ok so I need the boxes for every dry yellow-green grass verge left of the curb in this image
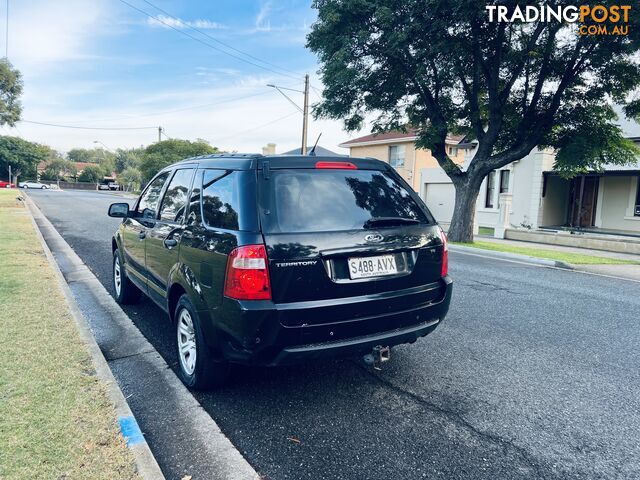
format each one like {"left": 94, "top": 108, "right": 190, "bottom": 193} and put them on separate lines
{"left": 0, "top": 190, "right": 138, "bottom": 479}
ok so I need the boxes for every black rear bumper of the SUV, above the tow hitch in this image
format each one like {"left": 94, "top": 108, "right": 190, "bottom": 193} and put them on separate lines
{"left": 208, "top": 277, "right": 453, "bottom": 366}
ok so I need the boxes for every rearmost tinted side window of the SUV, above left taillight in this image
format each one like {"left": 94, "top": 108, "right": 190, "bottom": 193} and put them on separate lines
{"left": 202, "top": 170, "right": 257, "bottom": 230}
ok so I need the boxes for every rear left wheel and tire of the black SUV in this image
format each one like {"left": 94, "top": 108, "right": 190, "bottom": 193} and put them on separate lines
{"left": 174, "top": 294, "right": 229, "bottom": 390}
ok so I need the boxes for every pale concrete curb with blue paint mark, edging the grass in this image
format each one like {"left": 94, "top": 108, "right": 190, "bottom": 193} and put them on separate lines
{"left": 25, "top": 197, "right": 165, "bottom": 480}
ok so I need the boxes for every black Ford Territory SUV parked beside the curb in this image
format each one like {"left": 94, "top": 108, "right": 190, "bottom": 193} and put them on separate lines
{"left": 109, "top": 154, "right": 452, "bottom": 388}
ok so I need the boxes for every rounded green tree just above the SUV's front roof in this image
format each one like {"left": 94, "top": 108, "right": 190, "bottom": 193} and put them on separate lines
{"left": 140, "top": 139, "right": 219, "bottom": 182}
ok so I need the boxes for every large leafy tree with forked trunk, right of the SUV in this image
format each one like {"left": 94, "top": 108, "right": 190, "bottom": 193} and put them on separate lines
{"left": 307, "top": 0, "right": 640, "bottom": 242}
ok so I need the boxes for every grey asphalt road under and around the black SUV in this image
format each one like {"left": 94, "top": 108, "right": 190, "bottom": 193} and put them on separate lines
{"left": 29, "top": 191, "right": 640, "bottom": 480}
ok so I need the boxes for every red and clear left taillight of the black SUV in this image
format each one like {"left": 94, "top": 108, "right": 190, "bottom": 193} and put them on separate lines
{"left": 224, "top": 245, "right": 271, "bottom": 300}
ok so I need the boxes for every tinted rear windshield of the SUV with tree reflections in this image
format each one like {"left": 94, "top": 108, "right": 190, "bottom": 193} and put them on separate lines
{"left": 263, "top": 170, "right": 431, "bottom": 233}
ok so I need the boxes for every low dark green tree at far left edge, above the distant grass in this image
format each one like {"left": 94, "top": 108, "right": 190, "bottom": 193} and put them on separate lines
{"left": 0, "top": 136, "right": 51, "bottom": 180}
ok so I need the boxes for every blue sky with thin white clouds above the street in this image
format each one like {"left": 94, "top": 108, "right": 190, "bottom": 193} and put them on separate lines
{"left": 0, "top": 0, "right": 360, "bottom": 153}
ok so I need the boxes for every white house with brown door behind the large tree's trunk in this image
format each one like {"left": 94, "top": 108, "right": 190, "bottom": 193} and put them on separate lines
{"left": 419, "top": 138, "right": 640, "bottom": 236}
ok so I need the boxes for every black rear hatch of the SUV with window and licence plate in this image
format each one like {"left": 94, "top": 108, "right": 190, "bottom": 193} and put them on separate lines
{"left": 258, "top": 162, "right": 443, "bottom": 326}
